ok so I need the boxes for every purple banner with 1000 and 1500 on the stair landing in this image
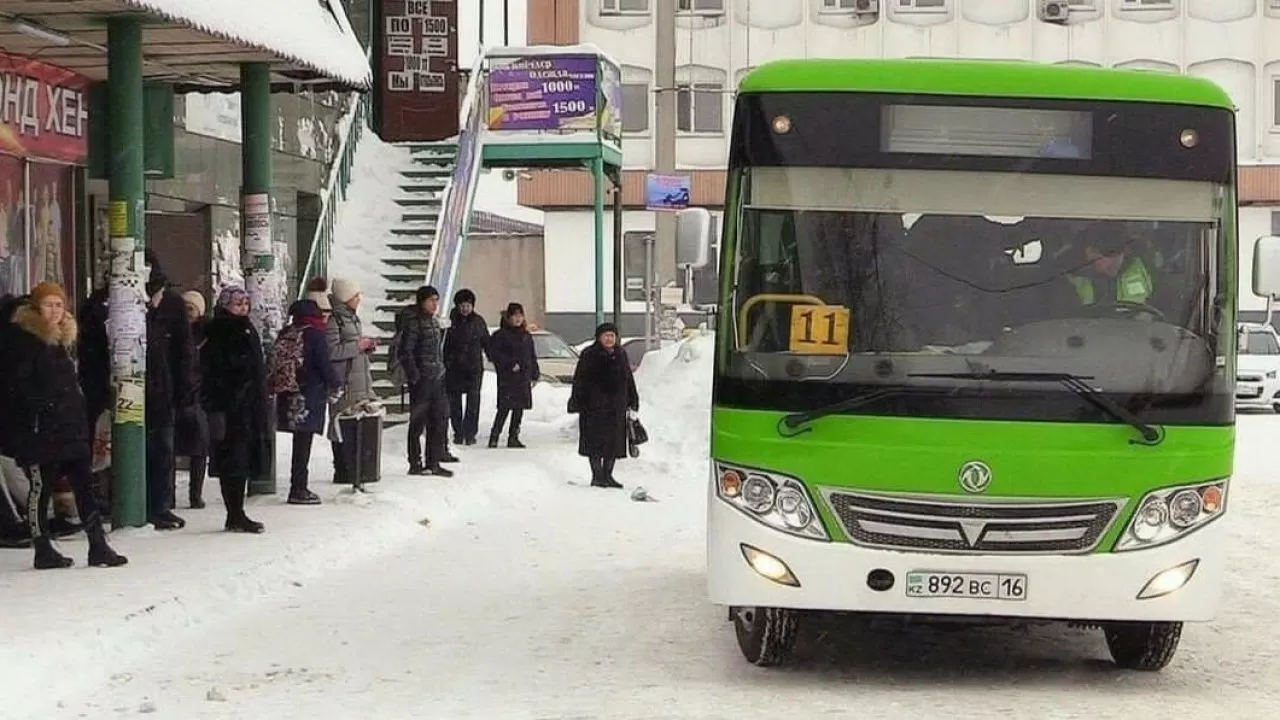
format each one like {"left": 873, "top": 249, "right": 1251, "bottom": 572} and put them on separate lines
{"left": 489, "top": 55, "right": 598, "bottom": 131}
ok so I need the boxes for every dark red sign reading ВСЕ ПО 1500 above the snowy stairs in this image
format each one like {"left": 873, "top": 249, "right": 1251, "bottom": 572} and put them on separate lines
{"left": 374, "top": 0, "right": 461, "bottom": 142}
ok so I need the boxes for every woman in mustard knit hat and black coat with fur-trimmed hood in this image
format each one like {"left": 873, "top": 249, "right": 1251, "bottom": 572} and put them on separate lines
{"left": 0, "top": 282, "right": 128, "bottom": 570}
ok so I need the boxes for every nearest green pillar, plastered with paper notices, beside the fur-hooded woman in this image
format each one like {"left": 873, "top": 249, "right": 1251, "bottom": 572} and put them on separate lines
{"left": 106, "top": 15, "right": 147, "bottom": 528}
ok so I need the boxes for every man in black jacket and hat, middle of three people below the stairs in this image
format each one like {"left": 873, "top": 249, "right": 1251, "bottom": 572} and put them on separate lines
{"left": 444, "top": 290, "right": 489, "bottom": 445}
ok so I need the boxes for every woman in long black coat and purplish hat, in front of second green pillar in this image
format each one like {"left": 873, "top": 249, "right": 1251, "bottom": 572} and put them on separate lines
{"left": 200, "top": 287, "right": 271, "bottom": 533}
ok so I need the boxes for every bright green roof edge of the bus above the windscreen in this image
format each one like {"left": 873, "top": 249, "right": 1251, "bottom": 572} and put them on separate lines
{"left": 739, "top": 58, "right": 1235, "bottom": 110}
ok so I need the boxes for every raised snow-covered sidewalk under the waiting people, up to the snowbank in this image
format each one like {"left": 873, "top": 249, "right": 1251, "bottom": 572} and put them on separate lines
{"left": 0, "top": 338, "right": 709, "bottom": 716}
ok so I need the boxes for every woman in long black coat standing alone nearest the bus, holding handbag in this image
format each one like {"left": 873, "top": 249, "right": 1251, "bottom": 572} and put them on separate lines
{"left": 568, "top": 323, "right": 640, "bottom": 488}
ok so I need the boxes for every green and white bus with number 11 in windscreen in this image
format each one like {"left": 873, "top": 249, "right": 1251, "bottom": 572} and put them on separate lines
{"left": 677, "top": 59, "right": 1280, "bottom": 670}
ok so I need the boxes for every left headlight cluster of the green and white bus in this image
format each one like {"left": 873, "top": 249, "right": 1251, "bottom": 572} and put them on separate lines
{"left": 716, "top": 462, "right": 831, "bottom": 541}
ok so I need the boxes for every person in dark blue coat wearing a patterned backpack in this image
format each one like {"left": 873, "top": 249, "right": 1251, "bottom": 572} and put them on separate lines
{"left": 273, "top": 300, "right": 342, "bottom": 505}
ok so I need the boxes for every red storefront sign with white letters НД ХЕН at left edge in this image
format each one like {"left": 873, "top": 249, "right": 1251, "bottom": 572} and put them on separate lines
{"left": 0, "top": 53, "right": 88, "bottom": 164}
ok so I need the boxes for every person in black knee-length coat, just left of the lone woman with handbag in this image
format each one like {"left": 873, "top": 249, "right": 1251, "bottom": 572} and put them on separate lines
{"left": 489, "top": 302, "right": 540, "bottom": 448}
